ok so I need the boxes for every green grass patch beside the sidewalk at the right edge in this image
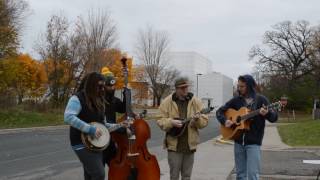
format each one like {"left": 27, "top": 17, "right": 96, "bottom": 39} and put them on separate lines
{"left": 278, "top": 115, "right": 320, "bottom": 146}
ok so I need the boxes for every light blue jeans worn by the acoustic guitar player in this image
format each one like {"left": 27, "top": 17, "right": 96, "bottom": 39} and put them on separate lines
{"left": 234, "top": 143, "right": 261, "bottom": 180}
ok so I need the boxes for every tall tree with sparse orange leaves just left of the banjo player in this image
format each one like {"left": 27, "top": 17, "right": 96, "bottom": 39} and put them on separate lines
{"left": 36, "top": 15, "right": 72, "bottom": 106}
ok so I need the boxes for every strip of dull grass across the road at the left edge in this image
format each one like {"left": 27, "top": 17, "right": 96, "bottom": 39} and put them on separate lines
{"left": 0, "top": 108, "right": 64, "bottom": 129}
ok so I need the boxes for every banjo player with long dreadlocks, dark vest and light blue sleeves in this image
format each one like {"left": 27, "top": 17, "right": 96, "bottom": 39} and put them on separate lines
{"left": 64, "top": 72, "right": 120, "bottom": 180}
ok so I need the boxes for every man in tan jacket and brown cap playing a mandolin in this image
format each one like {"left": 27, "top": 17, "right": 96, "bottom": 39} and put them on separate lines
{"left": 157, "top": 77, "right": 208, "bottom": 180}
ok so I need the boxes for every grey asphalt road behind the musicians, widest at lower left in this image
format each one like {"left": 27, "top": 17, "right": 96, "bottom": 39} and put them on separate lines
{"left": 0, "top": 118, "right": 218, "bottom": 179}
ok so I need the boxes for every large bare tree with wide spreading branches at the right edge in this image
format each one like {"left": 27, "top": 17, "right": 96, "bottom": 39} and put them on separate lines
{"left": 250, "top": 21, "right": 320, "bottom": 110}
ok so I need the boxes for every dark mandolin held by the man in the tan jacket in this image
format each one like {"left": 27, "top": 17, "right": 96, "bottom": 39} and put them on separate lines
{"left": 168, "top": 107, "right": 214, "bottom": 137}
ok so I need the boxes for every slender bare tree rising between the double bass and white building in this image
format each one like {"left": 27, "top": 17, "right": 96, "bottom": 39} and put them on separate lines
{"left": 135, "top": 26, "right": 176, "bottom": 106}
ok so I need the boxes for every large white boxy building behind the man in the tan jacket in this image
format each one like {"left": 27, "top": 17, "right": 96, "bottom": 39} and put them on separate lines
{"left": 167, "top": 52, "right": 233, "bottom": 107}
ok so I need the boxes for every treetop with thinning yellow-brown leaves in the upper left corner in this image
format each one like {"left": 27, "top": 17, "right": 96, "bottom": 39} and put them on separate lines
{"left": 0, "top": 0, "right": 29, "bottom": 58}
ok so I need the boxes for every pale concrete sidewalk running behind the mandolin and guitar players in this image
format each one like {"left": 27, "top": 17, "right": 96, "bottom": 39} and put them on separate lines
{"left": 159, "top": 121, "right": 290, "bottom": 180}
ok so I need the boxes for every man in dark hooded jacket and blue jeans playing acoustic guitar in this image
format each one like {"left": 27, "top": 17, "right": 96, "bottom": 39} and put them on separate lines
{"left": 216, "top": 75, "right": 278, "bottom": 180}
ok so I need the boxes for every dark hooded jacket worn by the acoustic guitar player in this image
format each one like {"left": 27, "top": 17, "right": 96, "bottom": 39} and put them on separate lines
{"left": 216, "top": 94, "right": 278, "bottom": 145}
